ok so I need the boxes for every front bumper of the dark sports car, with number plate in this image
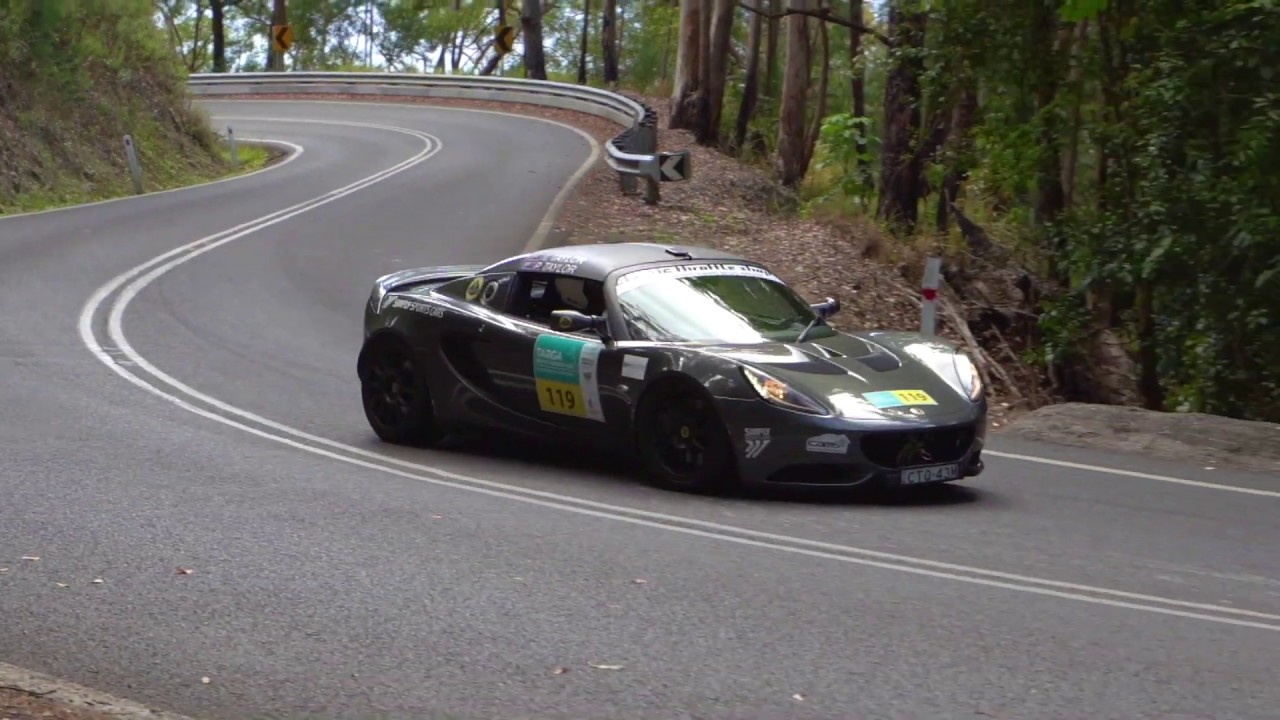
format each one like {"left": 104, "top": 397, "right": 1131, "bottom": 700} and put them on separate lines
{"left": 719, "top": 398, "right": 987, "bottom": 487}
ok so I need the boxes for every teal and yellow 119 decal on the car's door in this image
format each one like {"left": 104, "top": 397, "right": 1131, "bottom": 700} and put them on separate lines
{"left": 534, "top": 334, "right": 604, "bottom": 421}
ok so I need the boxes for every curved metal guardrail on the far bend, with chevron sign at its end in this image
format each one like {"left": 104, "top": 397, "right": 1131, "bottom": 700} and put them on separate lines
{"left": 188, "top": 72, "right": 692, "bottom": 205}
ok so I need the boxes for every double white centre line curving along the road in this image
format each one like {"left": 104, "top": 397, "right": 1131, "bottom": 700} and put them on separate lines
{"left": 78, "top": 112, "right": 1280, "bottom": 632}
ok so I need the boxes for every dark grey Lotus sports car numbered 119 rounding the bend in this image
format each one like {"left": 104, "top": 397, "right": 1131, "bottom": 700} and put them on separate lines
{"left": 357, "top": 243, "right": 987, "bottom": 491}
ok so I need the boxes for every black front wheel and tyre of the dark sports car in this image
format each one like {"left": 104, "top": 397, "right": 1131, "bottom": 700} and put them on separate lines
{"left": 636, "top": 382, "right": 737, "bottom": 493}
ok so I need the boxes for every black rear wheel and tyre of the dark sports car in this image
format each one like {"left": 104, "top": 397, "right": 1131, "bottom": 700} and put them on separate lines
{"left": 360, "top": 337, "right": 444, "bottom": 447}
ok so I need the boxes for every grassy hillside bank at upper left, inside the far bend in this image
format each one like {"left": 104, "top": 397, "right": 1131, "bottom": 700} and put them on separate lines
{"left": 0, "top": 0, "right": 248, "bottom": 213}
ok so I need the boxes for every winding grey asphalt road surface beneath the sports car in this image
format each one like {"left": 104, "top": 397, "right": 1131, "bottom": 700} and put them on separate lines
{"left": 0, "top": 102, "right": 1280, "bottom": 720}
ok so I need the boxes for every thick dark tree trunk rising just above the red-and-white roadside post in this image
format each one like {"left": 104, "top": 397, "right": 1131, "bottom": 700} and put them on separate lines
{"left": 877, "top": 0, "right": 925, "bottom": 233}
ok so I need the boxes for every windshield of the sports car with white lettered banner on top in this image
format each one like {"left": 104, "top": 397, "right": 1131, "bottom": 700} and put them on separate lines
{"left": 618, "top": 266, "right": 835, "bottom": 343}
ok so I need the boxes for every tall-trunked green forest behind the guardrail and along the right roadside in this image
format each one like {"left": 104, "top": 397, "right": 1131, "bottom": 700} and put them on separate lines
{"left": 155, "top": 0, "right": 1280, "bottom": 421}
